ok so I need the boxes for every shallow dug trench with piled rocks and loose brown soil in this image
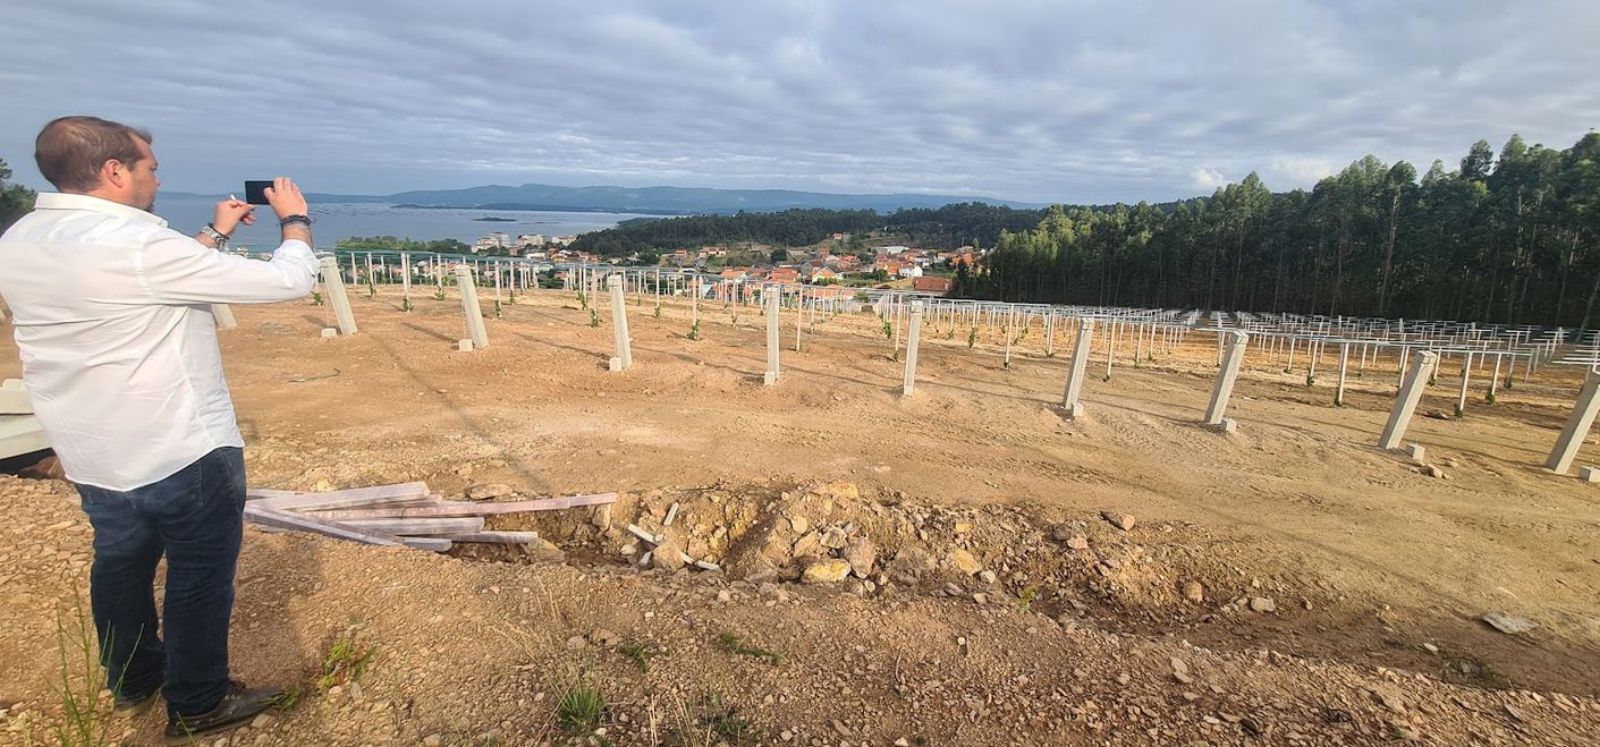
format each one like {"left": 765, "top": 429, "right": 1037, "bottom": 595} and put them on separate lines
{"left": 451, "top": 483, "right": 1600, "bottom": 696}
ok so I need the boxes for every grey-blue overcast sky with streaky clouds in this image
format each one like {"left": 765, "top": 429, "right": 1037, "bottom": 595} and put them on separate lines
{"left": 0, "top": 0, "right": 1600, "bottom": 203}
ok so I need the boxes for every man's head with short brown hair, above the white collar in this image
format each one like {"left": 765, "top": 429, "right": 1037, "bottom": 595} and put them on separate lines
{"left": 34, "top": 117, "right": 154, "bottom": 192}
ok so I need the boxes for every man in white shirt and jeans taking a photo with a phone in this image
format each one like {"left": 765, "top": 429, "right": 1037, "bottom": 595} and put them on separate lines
{"left": 0, "top": 117, "right": 317, "bottom": 737}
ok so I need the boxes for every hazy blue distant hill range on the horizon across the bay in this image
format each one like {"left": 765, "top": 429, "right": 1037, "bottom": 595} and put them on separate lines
{"left": 162, "top": 184, "right": 1042, "bottom": 216}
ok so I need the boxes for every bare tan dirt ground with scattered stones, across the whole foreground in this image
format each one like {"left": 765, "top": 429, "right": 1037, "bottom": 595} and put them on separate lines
{"left": 0, "top": 290, "right": 1600, "bottom": 745}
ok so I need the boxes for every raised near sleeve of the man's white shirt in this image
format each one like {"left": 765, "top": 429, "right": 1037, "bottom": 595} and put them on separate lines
{"left": 134, "top": 229, "right": 318, "bottom": 304}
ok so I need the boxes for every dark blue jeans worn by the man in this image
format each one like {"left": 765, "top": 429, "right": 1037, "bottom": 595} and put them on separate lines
{"left": 77, "top": 446, "right": 245, "bottom": 717}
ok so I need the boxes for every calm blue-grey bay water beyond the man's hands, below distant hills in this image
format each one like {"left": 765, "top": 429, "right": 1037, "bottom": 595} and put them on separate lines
{"left": 155, "top": 195, "right": 661, "bottom": 250}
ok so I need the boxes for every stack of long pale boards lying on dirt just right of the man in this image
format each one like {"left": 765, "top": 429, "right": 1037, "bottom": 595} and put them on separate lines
{"left": 245, "top": 483, "right": 616, "bottom": 552}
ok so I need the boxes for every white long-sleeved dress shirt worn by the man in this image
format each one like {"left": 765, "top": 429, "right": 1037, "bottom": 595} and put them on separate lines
{"left": 0, "top": 194, "right": 317, "bottom": 491}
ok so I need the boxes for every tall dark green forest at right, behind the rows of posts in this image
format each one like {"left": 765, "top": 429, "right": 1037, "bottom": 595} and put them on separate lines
{"left": 955, "top": 133, "right": 1600, "bottom": 328}
